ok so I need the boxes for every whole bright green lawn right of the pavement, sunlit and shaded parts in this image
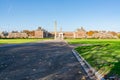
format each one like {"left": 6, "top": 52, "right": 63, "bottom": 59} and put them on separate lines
{"left": 66, "top": 39, "right": 120, "bottom": 77}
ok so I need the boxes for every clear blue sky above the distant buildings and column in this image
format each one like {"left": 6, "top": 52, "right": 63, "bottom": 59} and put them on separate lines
{"left": 0, "top": 0, "right": 120, "bottom": 32}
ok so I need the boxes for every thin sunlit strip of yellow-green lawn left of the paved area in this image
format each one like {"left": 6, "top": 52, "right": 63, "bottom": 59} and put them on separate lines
{"left": 0, "top": 39, "right": 49, "bottom": 45}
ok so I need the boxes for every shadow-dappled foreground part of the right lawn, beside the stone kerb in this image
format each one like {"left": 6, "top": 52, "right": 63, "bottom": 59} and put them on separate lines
{"left": 75, "top": 44, "right": 120, "bottom": 80}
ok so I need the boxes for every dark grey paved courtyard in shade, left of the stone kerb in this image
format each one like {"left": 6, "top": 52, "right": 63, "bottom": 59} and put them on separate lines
{"left": 0, "top": 41, "right": 88, "bottom": 80}
